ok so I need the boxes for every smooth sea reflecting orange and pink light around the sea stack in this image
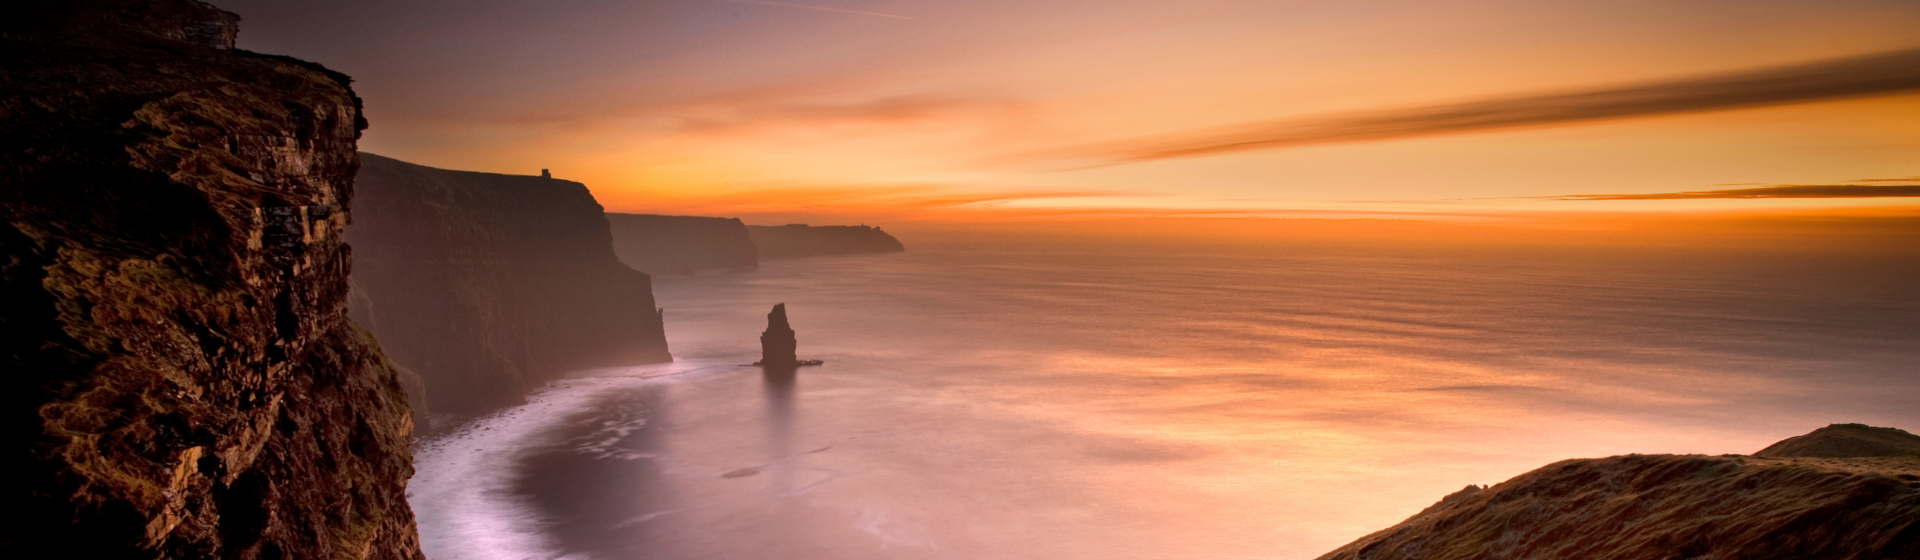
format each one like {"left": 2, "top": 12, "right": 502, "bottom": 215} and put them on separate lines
{"left": 411, "top": 240, "right": 1920, "bottom": 560}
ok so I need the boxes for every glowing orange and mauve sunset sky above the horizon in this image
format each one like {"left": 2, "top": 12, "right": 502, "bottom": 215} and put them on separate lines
{"left": 215, "top": 0, "right": 1920, "bottom": 231}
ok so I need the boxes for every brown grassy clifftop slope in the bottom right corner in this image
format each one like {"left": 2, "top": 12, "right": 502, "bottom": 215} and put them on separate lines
{"left": 1321, "top": 424, "right": 1920, "bottom": 560}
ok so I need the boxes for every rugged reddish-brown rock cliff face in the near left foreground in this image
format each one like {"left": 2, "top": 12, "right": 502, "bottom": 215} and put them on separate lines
{"left": 0, "top": 0, "right": 420, "bottom": 558}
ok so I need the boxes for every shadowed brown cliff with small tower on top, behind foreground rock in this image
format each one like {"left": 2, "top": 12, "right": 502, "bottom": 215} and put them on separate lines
{"left": 346, "top": 153, "right": 672, "bottom": 416}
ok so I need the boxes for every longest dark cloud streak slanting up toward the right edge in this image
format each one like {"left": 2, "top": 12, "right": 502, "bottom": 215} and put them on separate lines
{"left": 1012, "top": 48, "right": 1920, "bottom": 167}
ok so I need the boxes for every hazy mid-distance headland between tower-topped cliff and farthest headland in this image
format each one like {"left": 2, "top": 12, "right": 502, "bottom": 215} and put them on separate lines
{"left": 607, "top": 213, "right": 760, "bottom": 276}
